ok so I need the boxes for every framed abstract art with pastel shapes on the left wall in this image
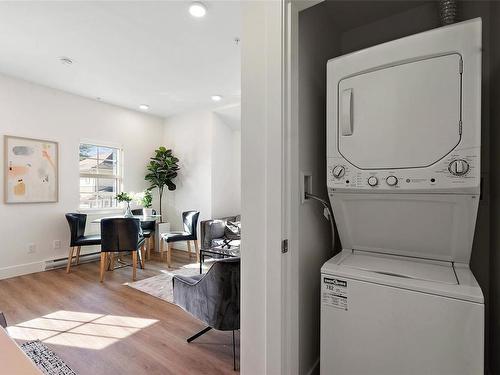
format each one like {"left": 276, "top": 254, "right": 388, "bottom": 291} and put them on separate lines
{"left": 4, "top": 135, "right": 59, "bottom": 203}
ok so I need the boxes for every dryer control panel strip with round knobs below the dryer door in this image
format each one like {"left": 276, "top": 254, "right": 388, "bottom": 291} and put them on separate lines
{"left": 327, "top": 148, "right": 480, "bottom": 191}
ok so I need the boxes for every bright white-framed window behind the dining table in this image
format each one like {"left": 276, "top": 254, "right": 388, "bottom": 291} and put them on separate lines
{"left": 80, "top": 143, "right": 122, "bottom": 209}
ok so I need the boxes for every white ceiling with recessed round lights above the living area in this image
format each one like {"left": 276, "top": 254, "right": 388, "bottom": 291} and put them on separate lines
{"left": 0, "top": 1, "right": 241, "bottom": 117}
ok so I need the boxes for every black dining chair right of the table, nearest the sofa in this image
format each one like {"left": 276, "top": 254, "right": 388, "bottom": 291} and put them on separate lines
{"left": 160, "top": 211, "right": 200, "bottom": 268}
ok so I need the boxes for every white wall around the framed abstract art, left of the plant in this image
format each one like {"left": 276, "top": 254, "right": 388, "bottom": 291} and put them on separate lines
{"left": 0, "top": 75, "right": 163, "bottom": 278}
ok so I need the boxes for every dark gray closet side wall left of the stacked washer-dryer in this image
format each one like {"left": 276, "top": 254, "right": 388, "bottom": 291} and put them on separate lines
{"left": 297, "top": 7, "right": 340, "bottom": 374}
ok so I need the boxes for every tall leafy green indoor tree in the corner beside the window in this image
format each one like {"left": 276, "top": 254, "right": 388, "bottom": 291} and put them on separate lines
{"left": 144, "top": 146, "right": 179, "bottom": 221}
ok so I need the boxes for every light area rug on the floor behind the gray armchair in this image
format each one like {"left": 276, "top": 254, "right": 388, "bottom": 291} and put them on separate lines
{"left": 127, "top": 263, "right": 205, "bottom": 303}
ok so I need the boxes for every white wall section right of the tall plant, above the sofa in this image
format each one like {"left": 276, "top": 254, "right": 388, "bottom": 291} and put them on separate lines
{"left": 163, "top": 111, "right": 241, "bottom": 241}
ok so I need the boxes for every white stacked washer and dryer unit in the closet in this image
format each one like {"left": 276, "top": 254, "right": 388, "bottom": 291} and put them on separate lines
{"left": 321, "top": 19, "right": 484, "bottom": 375}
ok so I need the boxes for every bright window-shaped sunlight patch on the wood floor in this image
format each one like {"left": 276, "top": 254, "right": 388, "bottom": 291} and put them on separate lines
{"left": 7, "top": 310, "right": 158, "bottom": 350}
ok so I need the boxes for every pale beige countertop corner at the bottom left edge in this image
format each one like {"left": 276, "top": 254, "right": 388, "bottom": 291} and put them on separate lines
{"left": 0, "top": 327, "right": 43, "bottom": 375}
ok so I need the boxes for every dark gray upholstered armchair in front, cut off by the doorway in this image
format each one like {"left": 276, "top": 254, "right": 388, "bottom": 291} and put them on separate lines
{"left": 172, "top": 258, "right": 240, "bottom": 370}
